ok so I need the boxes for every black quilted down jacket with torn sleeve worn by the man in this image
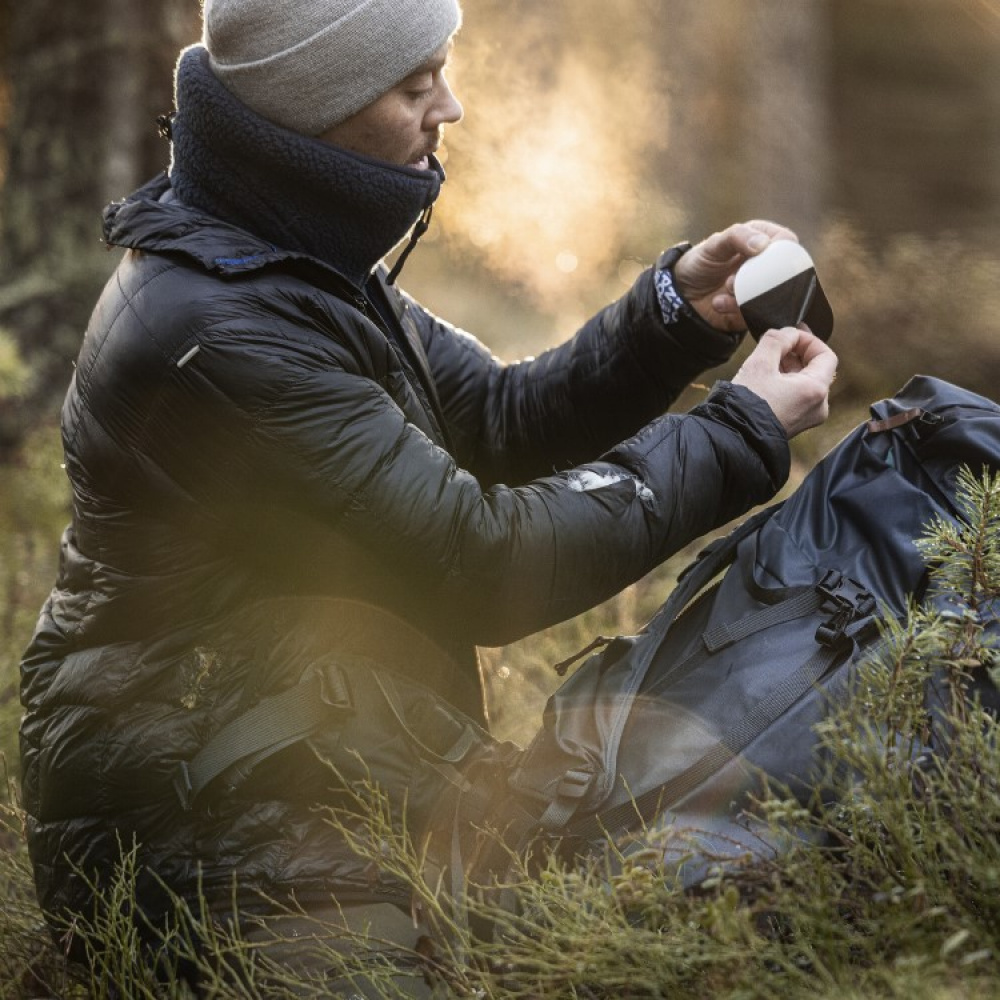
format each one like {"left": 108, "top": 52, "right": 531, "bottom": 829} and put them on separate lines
{"left": 22, "top": 172, "right": 788, "bottom": 928}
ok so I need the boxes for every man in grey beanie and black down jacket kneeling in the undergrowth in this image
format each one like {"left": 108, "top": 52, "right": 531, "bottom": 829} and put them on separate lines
{"left": 22, "top": 0, "right": 836, "bottom": 988}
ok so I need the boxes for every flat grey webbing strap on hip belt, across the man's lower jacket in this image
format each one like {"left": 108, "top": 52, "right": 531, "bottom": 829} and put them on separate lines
{"left": 174, "top": 664, "right": 351, "bottom": 810}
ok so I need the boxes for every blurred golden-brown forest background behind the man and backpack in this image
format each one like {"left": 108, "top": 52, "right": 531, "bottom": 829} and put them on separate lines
{"left": 0, "top": 0, "right": 1000, "bottom": 770}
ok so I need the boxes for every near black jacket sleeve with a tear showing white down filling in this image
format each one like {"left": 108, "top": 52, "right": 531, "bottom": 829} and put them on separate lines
{"left": 178, "top": 320, "right": 789, "bottom": 645}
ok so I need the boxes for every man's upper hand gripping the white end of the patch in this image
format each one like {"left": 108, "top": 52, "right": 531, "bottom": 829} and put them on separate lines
{"left": 674, "top": 219, "right": 798, "bottom": 333}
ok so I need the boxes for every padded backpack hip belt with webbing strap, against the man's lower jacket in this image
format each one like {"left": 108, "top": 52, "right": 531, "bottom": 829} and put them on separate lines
{"left": 170, "top": 597, "right": 488, "bottom": 809}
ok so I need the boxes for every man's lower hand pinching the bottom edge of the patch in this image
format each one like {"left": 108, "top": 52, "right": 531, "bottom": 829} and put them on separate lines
{"left": 733, "top": 326, "right": 837, "bottom": 438}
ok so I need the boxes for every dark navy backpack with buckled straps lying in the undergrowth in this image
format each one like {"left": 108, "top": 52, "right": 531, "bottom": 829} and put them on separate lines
{"left": 472, "top": 376, "right": 1000, "bottom": 884}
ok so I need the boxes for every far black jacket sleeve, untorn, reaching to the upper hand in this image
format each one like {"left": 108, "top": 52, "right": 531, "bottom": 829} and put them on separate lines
{"left": 398, "top": 270, "right": 741, "bottom": 483}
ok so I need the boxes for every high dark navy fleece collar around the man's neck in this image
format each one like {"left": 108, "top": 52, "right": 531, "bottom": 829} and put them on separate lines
{"left": 162, "top": 45, "right": 444, "bottom": 288}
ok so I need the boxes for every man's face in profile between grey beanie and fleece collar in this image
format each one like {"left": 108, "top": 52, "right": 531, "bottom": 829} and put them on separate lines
{"left": 318, "top": 42, "right": 462, "bottom": 170}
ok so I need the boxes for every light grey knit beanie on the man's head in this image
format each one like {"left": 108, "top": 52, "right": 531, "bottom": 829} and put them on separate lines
{"left": 203, "top": 0, "right": 462, "bottom": 135}
